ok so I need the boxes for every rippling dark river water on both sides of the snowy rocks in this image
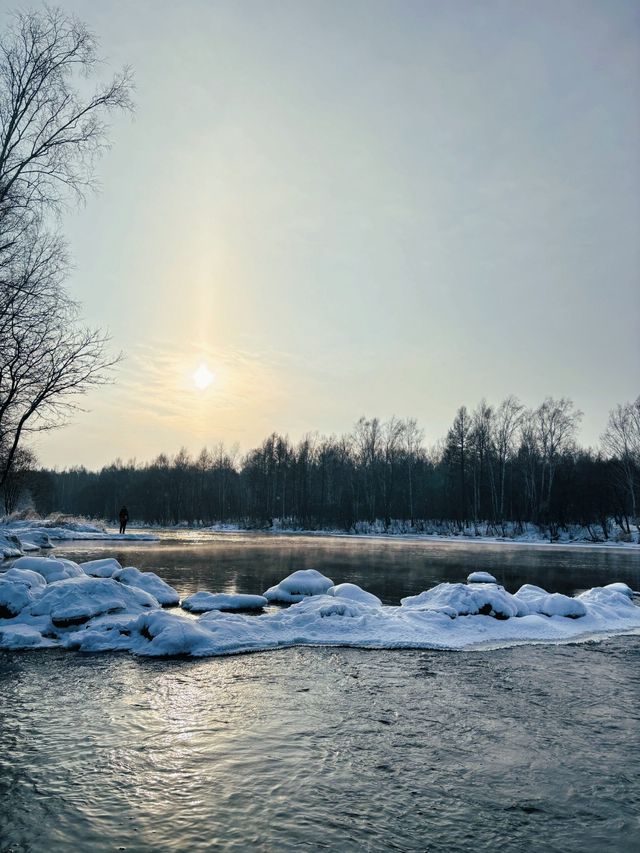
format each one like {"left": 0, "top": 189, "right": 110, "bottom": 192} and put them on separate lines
{"left": 0, "top": 534, "right": 640, "bottom": 853}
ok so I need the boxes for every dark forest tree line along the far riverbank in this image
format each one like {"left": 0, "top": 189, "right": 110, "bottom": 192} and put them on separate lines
{"left": 10, "top": 397, "right": 640, "bottom": 538}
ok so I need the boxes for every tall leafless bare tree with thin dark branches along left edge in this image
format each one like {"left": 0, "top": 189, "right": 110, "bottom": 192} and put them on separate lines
{"left": 0, "top": 8, "right": 131, "bottom": 486}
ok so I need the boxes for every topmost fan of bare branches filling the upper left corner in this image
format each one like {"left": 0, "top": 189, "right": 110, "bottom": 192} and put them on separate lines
{"left": 0, "top": 8, "right": 131, "bottom": 225}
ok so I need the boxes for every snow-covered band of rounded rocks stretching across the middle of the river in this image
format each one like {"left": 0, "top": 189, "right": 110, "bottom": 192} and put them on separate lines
{"left": 0, "top": 557, "right": 640, "bottom": 657}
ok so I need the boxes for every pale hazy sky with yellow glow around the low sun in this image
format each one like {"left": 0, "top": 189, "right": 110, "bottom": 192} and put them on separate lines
{"left": 2, "top": 0, "right": 640, "bottom": 466}
